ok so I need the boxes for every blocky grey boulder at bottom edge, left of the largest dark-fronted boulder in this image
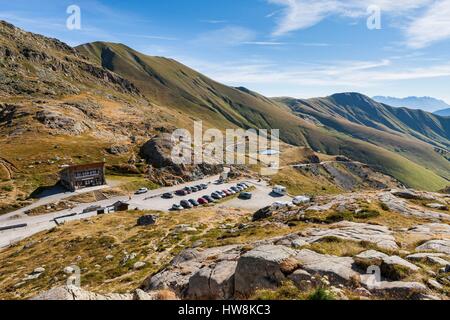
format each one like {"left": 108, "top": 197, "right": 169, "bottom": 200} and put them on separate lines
{"left": 187, "top": 261, "right": 237, "bottom": 300}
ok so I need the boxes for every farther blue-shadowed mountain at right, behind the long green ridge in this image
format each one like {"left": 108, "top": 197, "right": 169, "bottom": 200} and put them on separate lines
{"left": 276, "top": 94, "right": 450, "bottom": 188}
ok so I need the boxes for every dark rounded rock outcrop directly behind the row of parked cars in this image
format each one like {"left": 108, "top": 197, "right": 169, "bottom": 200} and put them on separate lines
{"left": 140, "top": 133, "right": 223, "bottom": 185}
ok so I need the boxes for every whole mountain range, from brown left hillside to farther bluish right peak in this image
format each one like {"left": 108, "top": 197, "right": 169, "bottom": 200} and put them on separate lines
{"left": 0, "top": 22, "right": 450, "bottom": 195}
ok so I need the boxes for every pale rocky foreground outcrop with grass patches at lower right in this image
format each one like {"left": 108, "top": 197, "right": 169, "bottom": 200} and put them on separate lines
{"left": 29, "top": 190, "right": 450, "bottom": 300}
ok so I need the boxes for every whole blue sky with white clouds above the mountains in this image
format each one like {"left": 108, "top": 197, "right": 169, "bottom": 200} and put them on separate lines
{"left": 0, "top": 0, "right": 450, "bottom": 110}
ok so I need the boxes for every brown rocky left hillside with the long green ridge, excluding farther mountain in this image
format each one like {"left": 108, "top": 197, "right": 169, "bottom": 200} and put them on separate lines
{"left": 0, "top": 19, "right": 450, "bottom": 202}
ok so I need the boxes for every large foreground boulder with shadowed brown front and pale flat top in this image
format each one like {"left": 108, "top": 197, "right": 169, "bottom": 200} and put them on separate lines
{"left": 235, "top": 245, "right": 296, "bottom": 297}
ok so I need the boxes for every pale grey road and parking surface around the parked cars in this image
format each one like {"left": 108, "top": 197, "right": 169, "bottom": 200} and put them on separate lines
{"left": 0, "top": 172, "right": 292, "bottom": 248}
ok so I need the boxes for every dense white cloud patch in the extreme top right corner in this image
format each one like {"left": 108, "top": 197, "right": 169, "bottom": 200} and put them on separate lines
{"left": 406, "top": 0, "right": 450, "bottom": 48}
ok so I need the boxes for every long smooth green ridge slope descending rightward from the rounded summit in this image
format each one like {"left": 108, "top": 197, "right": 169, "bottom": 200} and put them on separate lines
{"left": 77, "top": 42, "right": 449, "bottom": 189}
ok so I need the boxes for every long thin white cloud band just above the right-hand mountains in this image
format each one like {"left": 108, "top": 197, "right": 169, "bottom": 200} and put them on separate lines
{"left": 180, "top": 59, "right": 450, "bottom": 93}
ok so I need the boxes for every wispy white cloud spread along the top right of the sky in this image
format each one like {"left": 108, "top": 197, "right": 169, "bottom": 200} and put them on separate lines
{"left": 267, "top": 0, "right": 450, "bottom": 48}
